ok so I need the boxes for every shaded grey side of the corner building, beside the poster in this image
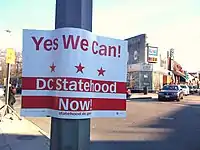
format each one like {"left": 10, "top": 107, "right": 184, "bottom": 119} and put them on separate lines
{"left": 126, "top": 34, "right": 152, "bottom": 90}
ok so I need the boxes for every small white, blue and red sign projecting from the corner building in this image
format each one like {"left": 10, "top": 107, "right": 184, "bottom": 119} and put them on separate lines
{"left": 147, "top": 46, "right": 158, "bottom": 63}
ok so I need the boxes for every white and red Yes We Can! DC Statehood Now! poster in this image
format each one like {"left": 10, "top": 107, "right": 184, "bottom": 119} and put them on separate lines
{"left": 21, "top": 28, "right": 128, "bottom": 119}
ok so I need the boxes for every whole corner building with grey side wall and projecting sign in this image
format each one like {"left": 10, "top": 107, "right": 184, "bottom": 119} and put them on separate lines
{"left": 126, "top": 34, "right": 172, "bottom": 92}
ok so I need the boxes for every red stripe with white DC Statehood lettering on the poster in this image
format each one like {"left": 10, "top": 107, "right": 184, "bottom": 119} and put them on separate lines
{"left": 22, "top": 77, "right": 126, "bottom": 93}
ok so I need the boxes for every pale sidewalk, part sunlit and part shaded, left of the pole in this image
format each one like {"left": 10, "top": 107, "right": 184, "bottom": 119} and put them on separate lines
{"left": 0, "top": 102, "right": 49, "bottom": 150}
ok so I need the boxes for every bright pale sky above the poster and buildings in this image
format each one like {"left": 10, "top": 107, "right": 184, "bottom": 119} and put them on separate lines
{"left": 0, "top": 0, "right": 200, "bottom": 71}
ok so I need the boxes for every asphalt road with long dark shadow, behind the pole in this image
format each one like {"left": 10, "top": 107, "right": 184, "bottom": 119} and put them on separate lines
{"left": 3, "top": 96, "right": 200, "bottom": 150}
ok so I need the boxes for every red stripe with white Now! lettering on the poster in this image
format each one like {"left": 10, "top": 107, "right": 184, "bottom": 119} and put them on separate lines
{"left": 22, "top": 96, "right": 126, "bottom": 111}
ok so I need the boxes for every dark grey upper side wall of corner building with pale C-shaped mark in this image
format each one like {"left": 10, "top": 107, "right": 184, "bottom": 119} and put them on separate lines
{"left": 126, "top": 34, "right": 146, "bottom": 65}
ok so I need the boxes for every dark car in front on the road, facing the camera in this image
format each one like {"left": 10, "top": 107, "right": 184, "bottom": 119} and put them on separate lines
{"left": 158, "top": 85, "right": 184, "bottom": 101}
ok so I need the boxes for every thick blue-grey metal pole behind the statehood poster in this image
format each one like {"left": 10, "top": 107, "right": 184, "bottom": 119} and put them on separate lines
{"left": 50, "top": 0, "right": 92, "bottom": 150}
